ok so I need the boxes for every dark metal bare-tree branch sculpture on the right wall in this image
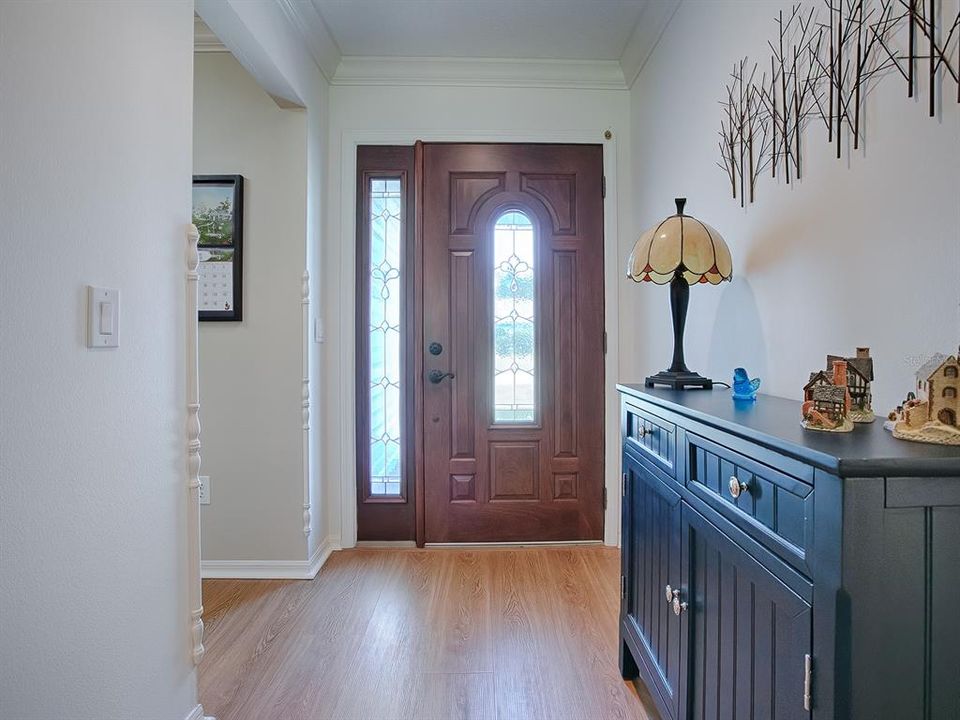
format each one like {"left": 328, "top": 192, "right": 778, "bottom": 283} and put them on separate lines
{"left": 718, "top": 0, "right": 960, "bottom": 206}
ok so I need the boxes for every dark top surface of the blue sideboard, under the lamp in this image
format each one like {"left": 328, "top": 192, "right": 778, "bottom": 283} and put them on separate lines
{"left": 617, "top": 384, "right": 960, "bottom": 479}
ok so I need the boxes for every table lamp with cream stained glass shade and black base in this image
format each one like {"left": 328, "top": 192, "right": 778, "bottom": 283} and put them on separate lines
{"left": 627, "top": 198, "right": 733, "bottom": 390}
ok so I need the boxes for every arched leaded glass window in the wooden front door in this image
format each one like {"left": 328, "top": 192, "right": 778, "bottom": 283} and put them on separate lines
{"left": 493, "top": 210, "right": 537, "bottom": 423}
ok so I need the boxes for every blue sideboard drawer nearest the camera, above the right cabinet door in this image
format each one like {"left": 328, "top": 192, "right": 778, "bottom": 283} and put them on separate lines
{"left": 685, "top": 433, "right": 813, "bottom": 575}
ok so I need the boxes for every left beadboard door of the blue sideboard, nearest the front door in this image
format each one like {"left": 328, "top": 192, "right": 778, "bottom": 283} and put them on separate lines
{"left": 623, "top": 453, "right": 681, "bottom": 717}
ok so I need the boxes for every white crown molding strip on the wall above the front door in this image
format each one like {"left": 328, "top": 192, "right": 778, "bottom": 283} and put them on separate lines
{"left": 331, "top": 56, "right": 627, "bottom": 90}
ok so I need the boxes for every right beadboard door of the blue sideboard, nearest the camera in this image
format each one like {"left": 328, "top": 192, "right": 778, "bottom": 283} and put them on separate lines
{"left": 680, "top": 503, "right": 811, "bottom": 720}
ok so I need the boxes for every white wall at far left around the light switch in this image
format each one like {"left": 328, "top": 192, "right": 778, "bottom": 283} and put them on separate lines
{"left": 0, "top": 0, "right": 196, "bottom": 720}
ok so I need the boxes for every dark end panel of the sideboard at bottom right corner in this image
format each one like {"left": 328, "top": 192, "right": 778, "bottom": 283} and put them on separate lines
{"left": 838, "top": 477, "right": 960, "bottom": 720}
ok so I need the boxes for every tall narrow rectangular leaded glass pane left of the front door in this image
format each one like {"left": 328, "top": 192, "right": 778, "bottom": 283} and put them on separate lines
{"left": 368, "top": 178, "right": 403, "bottom": 497}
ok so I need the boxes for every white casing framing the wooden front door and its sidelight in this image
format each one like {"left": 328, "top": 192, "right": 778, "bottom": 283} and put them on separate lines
{"left": 327, "top": 126, "right": 621, "bottom": 548}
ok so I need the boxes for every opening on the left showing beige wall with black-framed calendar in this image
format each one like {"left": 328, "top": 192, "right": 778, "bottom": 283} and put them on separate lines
{"left": 192, "top": 18, "right": 312, "bottom": 578}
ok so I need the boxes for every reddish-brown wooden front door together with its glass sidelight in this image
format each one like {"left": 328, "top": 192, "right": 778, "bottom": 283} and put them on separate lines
{"left": 356, "top": 143, "right": 605, "bottom": 545}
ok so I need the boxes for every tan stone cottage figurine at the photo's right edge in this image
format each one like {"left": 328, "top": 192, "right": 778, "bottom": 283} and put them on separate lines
{"left": 886, "top": 349, "right": 960, "bottom": 445}
